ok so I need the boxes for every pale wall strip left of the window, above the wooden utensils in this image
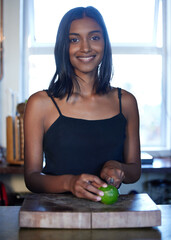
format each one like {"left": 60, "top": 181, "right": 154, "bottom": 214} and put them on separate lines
{"left": 0, "top": 0, "right": 22, "bottom": 147}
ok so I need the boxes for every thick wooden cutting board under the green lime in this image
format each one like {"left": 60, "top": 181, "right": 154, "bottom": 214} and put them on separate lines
{"left": 19, "top": 194, "right": 161, "bottom": 229}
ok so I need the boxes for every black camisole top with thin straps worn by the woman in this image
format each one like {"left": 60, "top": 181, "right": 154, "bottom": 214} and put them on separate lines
{"left": 42, "top": 88, "right": 127, "bottom": 176}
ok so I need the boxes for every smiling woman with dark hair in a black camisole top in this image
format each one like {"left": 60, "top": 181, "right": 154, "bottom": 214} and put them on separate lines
{"left": 24, "top": 7, "right": 141, "bottom": 201}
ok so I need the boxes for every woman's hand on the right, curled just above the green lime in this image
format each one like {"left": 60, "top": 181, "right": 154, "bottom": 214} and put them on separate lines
{"left": 100, "top": 160, "right": 125, "bottom": 188}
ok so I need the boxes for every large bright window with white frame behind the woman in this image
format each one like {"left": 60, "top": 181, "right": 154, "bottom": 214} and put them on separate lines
{"left": 24, "top": 0, "right": 170, "bottom": 153}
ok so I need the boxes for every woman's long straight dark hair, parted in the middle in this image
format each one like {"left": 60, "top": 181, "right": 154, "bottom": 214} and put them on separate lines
{"left": 48, "top": 7, "right": 112, "bottom": 98}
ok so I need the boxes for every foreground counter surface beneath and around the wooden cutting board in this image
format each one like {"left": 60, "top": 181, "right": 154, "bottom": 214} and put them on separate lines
{"left": 0, "top": 205, "right": 171, "bottom": 240}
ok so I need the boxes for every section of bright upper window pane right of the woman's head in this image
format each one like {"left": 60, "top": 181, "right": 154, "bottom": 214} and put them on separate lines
{"left": 98, "top": 0, "right": 155, "bottom": 44}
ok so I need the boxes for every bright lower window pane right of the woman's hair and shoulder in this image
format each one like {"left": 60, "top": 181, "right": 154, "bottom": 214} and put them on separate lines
{"left": 112, "top": 55, "right": 162, "bottom": 147}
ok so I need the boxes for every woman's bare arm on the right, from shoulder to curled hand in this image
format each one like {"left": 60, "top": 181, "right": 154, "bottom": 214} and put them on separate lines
{"left": 101, "top": 91, "right": 141, "bottom": 187}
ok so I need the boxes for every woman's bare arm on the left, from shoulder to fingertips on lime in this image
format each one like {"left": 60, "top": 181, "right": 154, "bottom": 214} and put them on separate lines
{"left": 24, "top": 92, "right": 105, "bottom": 201}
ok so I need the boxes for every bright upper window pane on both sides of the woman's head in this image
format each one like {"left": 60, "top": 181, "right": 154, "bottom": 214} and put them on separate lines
{"left": 34, "top": 0, "right": 162, "bottom": 44}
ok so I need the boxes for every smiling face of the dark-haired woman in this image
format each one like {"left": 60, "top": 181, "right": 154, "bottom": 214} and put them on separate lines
{"left": 69, "top": 17, "right": 104, "bottom": 76}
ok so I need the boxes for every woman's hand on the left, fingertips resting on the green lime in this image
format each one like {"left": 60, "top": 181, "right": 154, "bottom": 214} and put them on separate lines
{"left": 70, "top": 174, "right": 107, "bottom": 202}
